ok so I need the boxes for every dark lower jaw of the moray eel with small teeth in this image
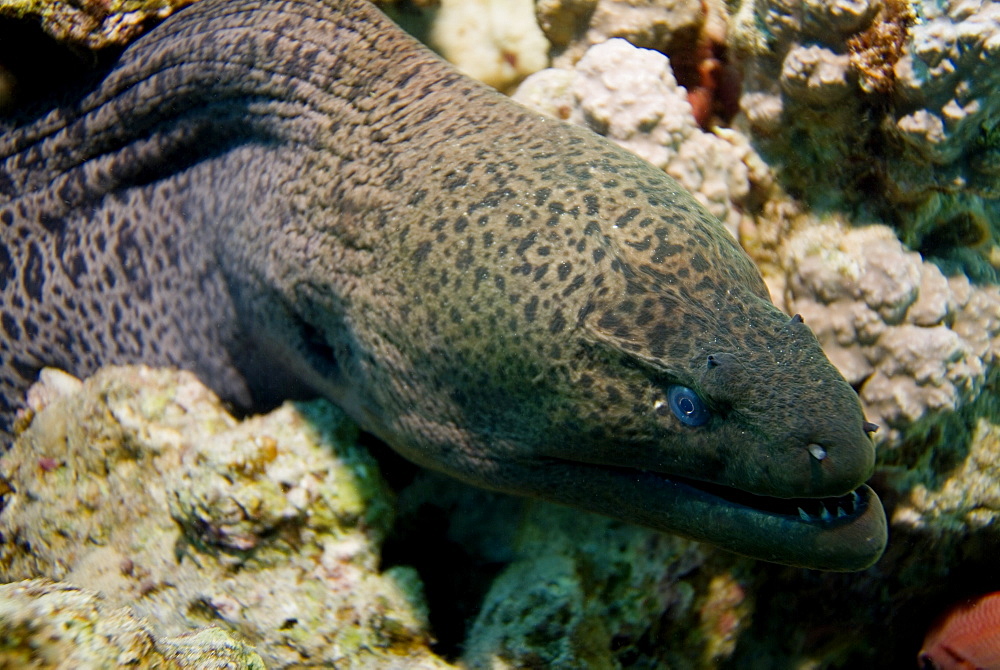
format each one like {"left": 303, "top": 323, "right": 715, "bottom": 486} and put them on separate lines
{"left": 521, "top": 460, "right": 888, "bottom": 572}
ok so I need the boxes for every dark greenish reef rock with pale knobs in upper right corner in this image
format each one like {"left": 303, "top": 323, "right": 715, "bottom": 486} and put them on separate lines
{"left": 728, "top": 0, "right": 1000, "bottom": 268}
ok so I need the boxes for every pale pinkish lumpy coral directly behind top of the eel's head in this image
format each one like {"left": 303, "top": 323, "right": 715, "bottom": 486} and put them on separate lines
{"left": 514, "top": 39, "right": 766, "bottom": 231}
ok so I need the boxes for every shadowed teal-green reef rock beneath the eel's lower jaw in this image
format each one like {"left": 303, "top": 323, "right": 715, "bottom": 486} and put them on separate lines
{"left": 390, "top": 471, "right": 754, "bottom": 670}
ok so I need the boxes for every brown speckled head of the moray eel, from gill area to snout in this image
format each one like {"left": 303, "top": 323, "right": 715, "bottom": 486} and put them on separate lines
{"left": 280, "top": 98, "right": 886, "bottom": 570}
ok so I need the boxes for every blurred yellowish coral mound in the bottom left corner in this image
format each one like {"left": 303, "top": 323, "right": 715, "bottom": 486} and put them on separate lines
{"left": 0, "top": 579, "right": 265, "bottom": 670}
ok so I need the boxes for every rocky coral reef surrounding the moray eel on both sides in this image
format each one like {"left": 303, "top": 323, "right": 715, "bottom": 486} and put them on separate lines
{"left": 0, "top": 0, "right": 1000, "bottom": 668}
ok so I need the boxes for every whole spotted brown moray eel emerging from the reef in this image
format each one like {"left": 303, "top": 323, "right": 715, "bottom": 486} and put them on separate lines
{"left": 0, "top": 0, "right": 886, "bottom": 570}
